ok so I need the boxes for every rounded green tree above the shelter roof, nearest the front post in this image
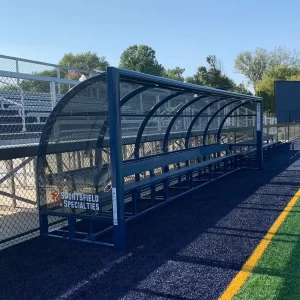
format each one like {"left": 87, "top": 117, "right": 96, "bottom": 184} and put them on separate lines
{"left": 120, "top": 45, "right": 165, "bottom": 76}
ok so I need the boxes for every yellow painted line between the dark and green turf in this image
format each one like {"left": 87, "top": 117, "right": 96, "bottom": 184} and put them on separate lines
{"left": 219, "top": 189, "right": 300, "bottom": 300}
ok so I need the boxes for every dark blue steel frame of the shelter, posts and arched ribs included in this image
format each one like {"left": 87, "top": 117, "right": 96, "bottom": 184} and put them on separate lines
{"left": 37, "top": 67, "right": 263, "bottom": 251}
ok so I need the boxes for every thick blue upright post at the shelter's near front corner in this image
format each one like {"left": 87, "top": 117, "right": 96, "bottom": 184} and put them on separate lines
{"left": 107, "top": 67, "right": 126, "bottom": 251}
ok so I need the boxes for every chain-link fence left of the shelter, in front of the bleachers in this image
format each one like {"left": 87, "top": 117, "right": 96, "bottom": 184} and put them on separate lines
{"left": 0, "top": 68, "right": 78, "bottom": 249}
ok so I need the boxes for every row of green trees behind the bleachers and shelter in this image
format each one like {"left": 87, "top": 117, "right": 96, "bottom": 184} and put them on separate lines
{"left": 12, "top": 45, "right": 300, "bottom": 113}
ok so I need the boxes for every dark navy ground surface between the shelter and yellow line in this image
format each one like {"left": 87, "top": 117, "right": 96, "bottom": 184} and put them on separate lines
{"left": 0, "top": 141, "right": 300, "bottom": 300}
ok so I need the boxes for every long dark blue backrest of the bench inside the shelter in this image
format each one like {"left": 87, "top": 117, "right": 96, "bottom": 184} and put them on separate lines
{"left": 123, "top": 144, "right": 229, "bottom": 177}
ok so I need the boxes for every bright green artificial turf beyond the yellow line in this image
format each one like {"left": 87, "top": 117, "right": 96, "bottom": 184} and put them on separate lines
{"left": 234, "top": 199, "right": 300, "bottom": 300}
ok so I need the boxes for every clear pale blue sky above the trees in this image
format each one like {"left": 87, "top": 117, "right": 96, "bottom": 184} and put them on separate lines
{"left": 0, "top": 0, "right": 300, "bottom": 86}
